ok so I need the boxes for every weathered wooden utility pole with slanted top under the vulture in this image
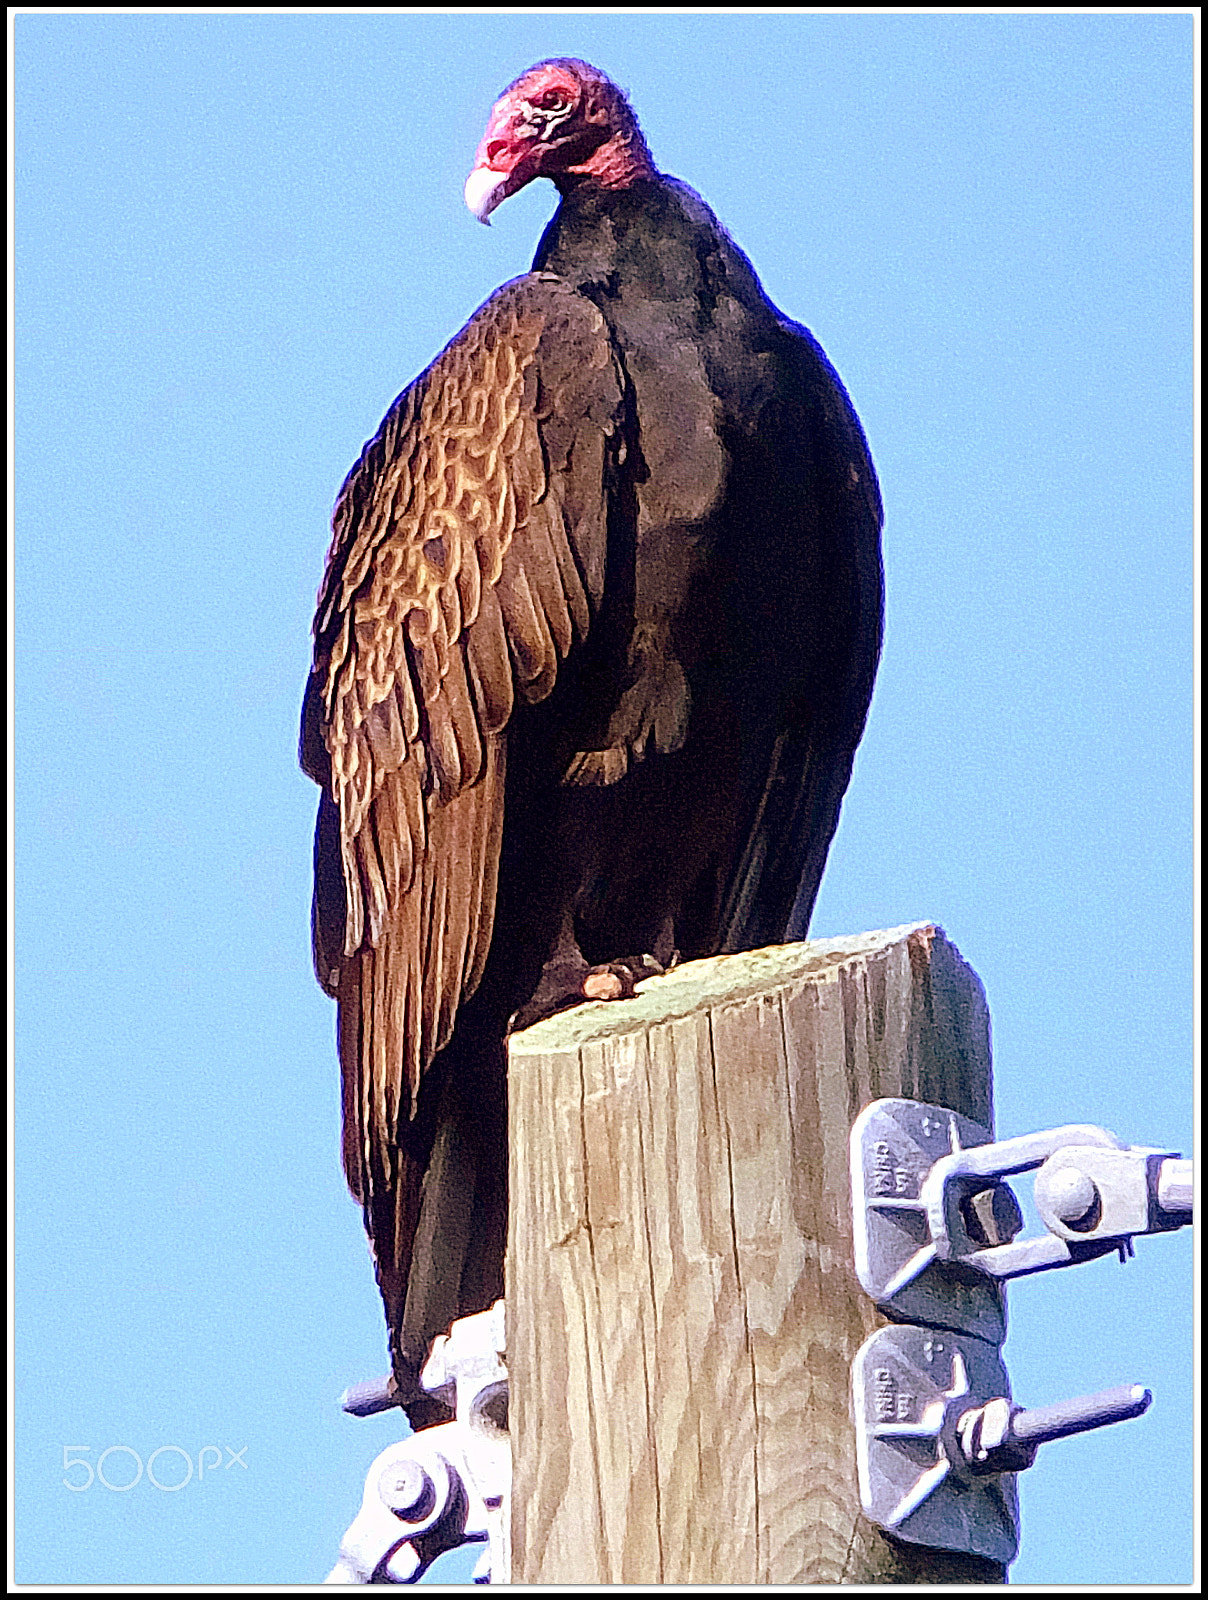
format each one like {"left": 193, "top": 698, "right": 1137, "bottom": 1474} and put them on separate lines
{"left": 507, "top": 923, "right": 1005, "bottom": 1586}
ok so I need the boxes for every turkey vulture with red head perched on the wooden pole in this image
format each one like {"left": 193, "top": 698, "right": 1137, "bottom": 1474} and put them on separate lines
{"left": 301, "top": 59, "right": 882, "bottom": 1426}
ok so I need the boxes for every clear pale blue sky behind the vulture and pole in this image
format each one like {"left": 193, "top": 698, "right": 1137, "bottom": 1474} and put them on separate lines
{"left": 14, "top": 11, "right": 1194, "bottom": 1586}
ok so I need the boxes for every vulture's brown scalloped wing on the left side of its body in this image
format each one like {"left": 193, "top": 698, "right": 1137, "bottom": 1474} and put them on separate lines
{"left": 302, "top": 274, "right": 621, "bottom": 1209}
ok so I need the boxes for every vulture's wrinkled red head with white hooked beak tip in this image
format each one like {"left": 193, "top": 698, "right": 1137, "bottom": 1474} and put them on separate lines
{"left": 466, "top": 58, "right": 654, "bottom": 222}
